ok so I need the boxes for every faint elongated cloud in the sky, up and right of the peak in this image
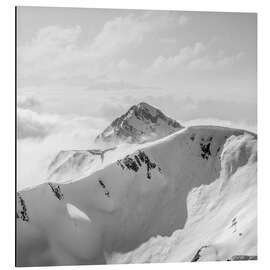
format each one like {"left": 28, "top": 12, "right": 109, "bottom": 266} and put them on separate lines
{"left": 146, "top": 42, "right": 244, "bottom": 75}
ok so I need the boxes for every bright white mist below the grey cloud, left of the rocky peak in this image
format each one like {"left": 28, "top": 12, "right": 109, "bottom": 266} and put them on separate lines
{"left": 17, "top": 126, "right": 98, "bottom": 190}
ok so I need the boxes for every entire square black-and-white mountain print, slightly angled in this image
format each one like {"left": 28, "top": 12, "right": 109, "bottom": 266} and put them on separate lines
{"left": 13, "top": 6, "right": 258, "bottom": 267}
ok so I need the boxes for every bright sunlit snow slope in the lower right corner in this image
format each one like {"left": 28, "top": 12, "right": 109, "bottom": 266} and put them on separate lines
{"left": 107, "top": 135, "right": 257, "bottom": 263}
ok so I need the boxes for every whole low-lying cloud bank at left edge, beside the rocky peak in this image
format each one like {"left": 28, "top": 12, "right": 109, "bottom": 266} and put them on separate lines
{"left": 17, "top": 98, "right": 108, "bottom": 190}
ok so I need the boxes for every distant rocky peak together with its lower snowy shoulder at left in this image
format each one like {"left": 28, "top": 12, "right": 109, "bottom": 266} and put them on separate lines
{"left": 47, "top": 102, "right": 183, "bottom": 183}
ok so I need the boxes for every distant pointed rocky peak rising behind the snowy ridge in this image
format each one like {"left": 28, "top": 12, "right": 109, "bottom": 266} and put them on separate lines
{"left": 96, "top": 102, "right": 183, "bottom": 144}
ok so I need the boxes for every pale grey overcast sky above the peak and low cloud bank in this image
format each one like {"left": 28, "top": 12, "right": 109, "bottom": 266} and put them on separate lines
{"left": 17, "top": 7, "right": 257, "bottom": 131}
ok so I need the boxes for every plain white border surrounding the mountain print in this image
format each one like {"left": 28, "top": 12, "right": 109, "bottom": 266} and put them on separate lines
{"left": 0, "top": 0, "right": 270, "bottom": 270}
